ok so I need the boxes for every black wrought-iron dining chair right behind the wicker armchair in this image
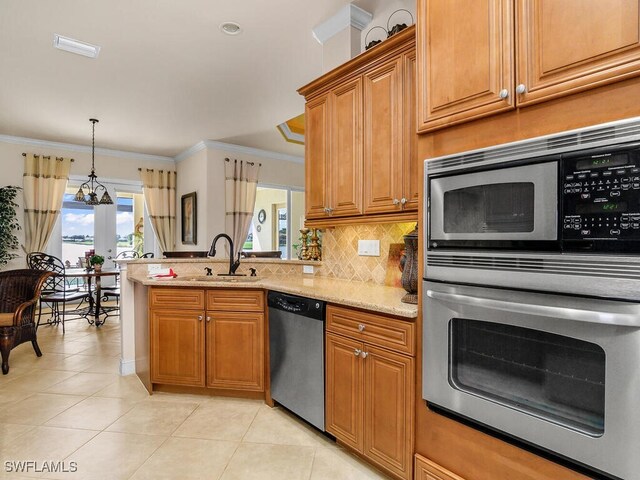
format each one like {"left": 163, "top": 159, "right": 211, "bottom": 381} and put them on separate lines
{"left": 27, "top": 252, "right": 91, "bottom": 333}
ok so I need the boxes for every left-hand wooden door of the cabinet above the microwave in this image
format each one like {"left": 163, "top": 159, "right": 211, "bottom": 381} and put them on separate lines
{"left": 417, "top": 0, "right": 516, "bottom": 132}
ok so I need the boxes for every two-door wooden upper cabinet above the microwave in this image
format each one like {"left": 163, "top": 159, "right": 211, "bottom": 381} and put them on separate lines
{"left": 417, "top": 0, "right": 640, "bottom": 132}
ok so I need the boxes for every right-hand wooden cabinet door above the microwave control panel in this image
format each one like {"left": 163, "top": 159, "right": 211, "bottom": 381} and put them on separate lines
{"left": 516, "top": 0, "right": 640, "bottom": 105}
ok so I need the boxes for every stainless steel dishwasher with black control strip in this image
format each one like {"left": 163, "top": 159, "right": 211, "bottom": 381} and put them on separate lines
{"left": 267, "top": 292, "right": 325, "bottom": 432}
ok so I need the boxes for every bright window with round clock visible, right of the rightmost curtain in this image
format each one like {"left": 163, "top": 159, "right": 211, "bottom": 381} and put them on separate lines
{"left": 243, "top": 186, "right": 304, "bottom": 258}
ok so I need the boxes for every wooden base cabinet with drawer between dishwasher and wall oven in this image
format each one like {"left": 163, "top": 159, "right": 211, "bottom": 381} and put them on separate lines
{"left": 326, "top": 305, "right": 415, "bottom": 478}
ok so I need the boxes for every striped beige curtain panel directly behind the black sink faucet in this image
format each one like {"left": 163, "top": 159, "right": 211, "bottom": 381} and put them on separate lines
{"left": 224, "top": 158, "right": 261, "bottom": 258}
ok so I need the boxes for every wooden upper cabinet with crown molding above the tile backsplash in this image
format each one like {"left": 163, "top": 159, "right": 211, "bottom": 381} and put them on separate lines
{"left": 298, "top": 27, "right": 419, "bottom": 227}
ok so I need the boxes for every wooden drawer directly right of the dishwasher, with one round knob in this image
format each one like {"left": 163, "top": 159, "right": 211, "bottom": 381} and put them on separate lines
{"left": 327, "top": 305, "right": 415, "bottom": 355}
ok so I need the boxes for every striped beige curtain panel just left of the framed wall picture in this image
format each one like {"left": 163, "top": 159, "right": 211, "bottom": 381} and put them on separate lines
{"left": 139, "top": 168, "right": 176, "bottom": 252}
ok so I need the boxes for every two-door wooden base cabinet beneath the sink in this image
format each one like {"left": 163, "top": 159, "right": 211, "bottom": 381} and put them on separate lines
{"left": 149, "top": 287, "right": 264, "bottom": 392}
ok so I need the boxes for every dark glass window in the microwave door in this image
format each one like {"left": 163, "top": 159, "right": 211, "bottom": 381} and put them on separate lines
{"left": 444, "top": 182, "right": 534, "bottom": 233}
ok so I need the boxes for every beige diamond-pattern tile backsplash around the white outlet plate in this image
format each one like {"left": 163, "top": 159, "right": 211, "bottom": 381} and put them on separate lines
{"left": 316, "top": 222, "right": 416, "bottom": 285}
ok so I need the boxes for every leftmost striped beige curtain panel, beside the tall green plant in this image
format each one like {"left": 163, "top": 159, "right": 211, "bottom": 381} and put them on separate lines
{"left": 22, "top": 153, "right": 72, "bottom": 253}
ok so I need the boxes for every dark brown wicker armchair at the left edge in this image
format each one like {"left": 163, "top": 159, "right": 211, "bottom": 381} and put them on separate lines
{"left": 0, "top": 269, "right": 53, "bottom": 375}
